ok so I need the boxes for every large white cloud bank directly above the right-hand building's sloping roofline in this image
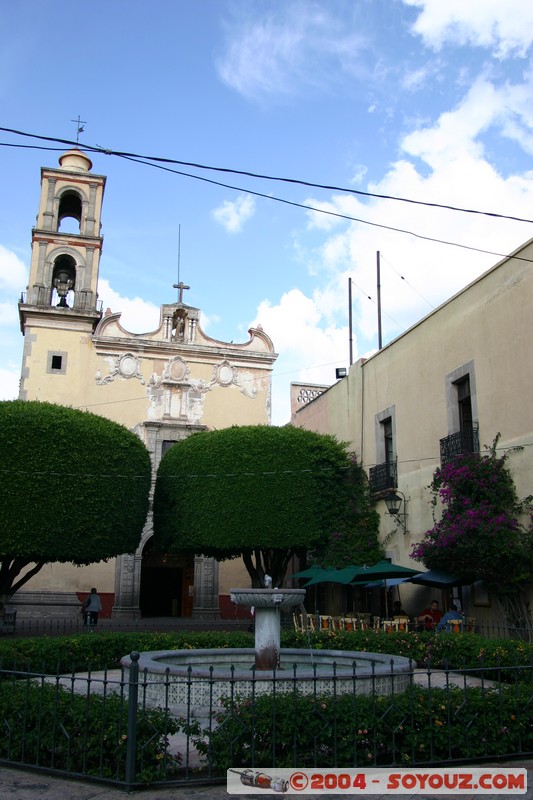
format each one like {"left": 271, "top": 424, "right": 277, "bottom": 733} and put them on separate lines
{"left": 264, "top": 70, "right": 533, "bottom": 407}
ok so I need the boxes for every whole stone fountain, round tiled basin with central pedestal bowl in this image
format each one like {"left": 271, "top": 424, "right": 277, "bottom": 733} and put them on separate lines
{"left": 121, "top": 581, "right": 416, "bottom": 717}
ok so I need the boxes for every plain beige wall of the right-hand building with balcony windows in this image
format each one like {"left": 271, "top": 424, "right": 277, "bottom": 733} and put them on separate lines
{"left": 293, "top": 242, "right": 533, "bottom": 619}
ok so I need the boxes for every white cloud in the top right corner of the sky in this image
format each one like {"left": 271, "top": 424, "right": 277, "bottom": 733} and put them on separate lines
{"left": 403, "top": 0, "right": 533, "bottom": 57}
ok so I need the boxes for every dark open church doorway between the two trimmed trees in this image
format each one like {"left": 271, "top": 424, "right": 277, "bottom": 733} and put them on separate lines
{"left": 139, "top": 539, "right": 194, "bottom": 617}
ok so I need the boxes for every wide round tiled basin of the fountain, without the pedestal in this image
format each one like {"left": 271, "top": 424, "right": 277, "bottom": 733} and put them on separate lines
{"left": 121, "top": 648, "right": 416, "bottom": 717}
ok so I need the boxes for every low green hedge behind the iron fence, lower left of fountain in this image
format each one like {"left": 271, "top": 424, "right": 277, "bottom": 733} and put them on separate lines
{"left": 0, "top": 675, "right": 180, "bottom": 781}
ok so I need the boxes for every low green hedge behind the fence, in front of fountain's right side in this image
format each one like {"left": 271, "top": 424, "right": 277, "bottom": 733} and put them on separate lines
{"left": 185, "top": 685, "right": 533, "bottom": 772}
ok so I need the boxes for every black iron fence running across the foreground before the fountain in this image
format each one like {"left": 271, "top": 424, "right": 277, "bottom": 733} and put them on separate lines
{"left": 0, "top": 654, "right": 533, "bottom": 789}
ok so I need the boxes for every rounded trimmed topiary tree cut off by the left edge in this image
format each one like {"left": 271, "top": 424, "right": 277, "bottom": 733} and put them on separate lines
{"left": 0, "top": 400, "right": 151, "bottom": 597}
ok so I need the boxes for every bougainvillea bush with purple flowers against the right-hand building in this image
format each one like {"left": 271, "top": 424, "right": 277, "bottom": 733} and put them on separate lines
{"left": 412, "top": 437, "right": 533, "bottom": 596}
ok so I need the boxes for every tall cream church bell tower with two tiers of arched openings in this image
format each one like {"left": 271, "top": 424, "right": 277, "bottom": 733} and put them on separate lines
{"left": 19, "top": 149, "right": 106, "bottom": 402}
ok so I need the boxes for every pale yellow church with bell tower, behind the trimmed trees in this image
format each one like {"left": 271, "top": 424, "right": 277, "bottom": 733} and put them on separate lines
{"left": 13, "top": 149, "right": 276, "bottom": 618}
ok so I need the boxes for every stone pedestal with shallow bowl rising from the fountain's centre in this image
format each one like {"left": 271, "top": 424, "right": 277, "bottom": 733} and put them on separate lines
{"left": 230, "top": 589, "right": 305, "bottom": 670}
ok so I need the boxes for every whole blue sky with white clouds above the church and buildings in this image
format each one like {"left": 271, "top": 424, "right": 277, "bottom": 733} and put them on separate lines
{"left": 0, "top": 0, "right": 533, "bottom": 424}
